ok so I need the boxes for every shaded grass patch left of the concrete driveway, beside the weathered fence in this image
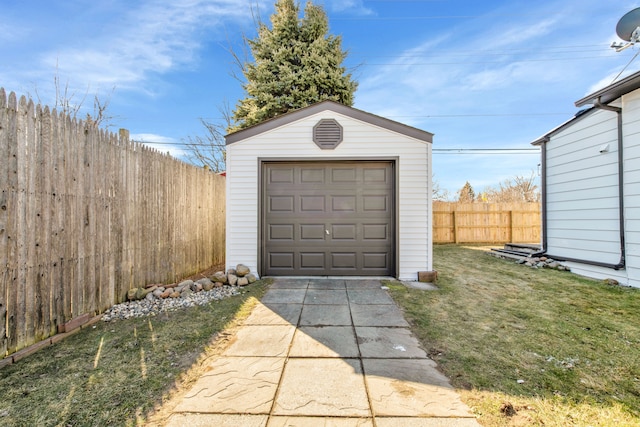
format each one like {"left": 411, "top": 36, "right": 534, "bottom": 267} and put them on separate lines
{"left": 0, "top": 281, "right": 268, "bottom": 426}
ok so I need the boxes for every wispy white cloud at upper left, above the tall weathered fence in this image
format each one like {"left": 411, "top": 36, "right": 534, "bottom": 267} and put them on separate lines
{"left": 13, "top": 0, "right": 255, "bottom": 101}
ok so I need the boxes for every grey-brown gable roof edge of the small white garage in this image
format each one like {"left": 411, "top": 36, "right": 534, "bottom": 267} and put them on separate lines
{"left": 224, "top": 101, "right": 433, "bottom": 145}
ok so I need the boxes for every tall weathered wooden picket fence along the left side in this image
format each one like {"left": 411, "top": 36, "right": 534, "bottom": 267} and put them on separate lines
{"left": 0, "top": 89, "right": 225, "bottom": 358}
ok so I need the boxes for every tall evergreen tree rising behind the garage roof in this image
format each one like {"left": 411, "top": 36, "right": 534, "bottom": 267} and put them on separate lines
{"left": 228, "top": 0, "right": 357, "bottom": 132}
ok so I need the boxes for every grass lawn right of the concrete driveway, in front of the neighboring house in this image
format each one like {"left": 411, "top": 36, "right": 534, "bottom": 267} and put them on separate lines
{"left": 390, "top": 245, "right": 640, "bottom": 426}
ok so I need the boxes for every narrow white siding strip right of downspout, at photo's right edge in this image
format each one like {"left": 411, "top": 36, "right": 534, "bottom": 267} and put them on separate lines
{"left": 622, "top": 90, "right": 640, "bottom": 287}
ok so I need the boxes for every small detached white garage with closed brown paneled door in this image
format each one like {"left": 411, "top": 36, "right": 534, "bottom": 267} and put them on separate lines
{"left": 226, "top": 101, "right": 433, "bottom": 280}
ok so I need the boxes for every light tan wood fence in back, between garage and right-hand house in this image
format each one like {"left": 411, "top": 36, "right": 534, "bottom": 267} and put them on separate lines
{"left": 433, "top": 202, "right": 541, "bottom": 243}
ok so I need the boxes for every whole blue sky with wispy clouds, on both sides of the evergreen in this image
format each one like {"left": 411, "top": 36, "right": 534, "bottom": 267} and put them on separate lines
{"left": 0, "top": 0, "right": 640, "bottom": 194}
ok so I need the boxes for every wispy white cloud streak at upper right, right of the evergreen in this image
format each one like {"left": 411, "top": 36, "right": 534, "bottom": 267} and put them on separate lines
{"left": 356, "top": 1, "right": 628, "bottom": 119}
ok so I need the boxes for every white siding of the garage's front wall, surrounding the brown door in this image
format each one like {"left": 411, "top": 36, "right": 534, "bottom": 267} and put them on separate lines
{"left": 226, "top": 111, "right": 432, "bottom": 280}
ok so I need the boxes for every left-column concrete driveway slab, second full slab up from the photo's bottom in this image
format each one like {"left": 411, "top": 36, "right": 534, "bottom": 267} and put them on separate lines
{"left": 223, "top": 325, "right": 296, "bottom": 357}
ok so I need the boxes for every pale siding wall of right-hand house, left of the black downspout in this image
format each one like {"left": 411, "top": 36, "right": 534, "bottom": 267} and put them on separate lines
{"left": 546, "top": 110, "right": 620, "bottom": 264}
